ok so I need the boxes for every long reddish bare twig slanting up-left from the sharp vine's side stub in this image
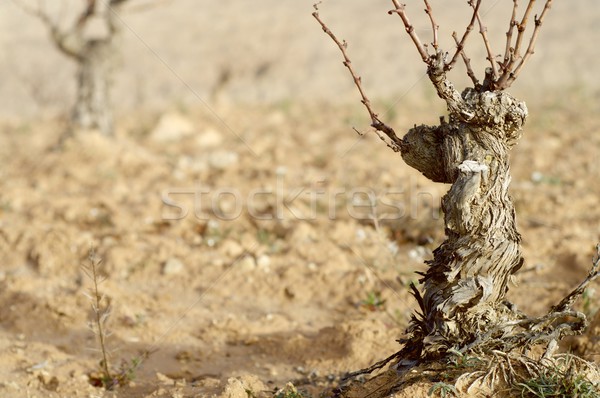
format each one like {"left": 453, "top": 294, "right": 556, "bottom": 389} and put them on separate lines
{"left": 312, "top": 4, "right": 404, "bottom": 152}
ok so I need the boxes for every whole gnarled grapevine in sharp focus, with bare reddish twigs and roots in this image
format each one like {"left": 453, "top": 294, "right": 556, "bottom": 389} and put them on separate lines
{"left": 313, "top": 5, "right": 600, "bottom": 397}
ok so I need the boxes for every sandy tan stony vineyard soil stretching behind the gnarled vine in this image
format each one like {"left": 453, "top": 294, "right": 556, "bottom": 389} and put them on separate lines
{"left": 0, "top": 0, "right": 600, "bottom": 397}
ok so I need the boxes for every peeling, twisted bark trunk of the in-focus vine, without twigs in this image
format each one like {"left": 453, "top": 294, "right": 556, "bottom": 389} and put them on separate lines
{"left": 402, "top": 60, "right": 527, "bottom": 356}
